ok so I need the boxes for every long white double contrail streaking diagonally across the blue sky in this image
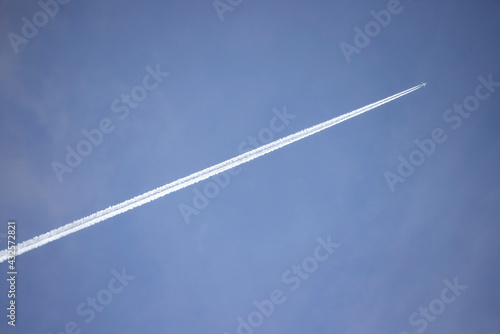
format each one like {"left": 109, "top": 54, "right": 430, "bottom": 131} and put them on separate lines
{"left": 0, "top": 84, "right": 424, "bottom": 263}
